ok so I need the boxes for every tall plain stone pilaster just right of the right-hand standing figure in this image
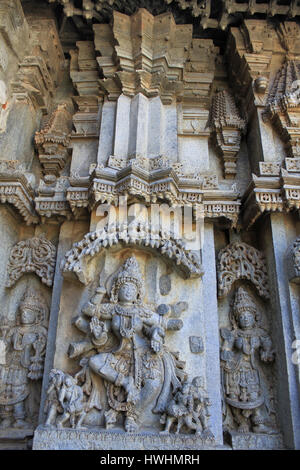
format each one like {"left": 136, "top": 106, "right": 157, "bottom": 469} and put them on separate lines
{"left": 262, "top": 213, "right": 300, "bottom": 449}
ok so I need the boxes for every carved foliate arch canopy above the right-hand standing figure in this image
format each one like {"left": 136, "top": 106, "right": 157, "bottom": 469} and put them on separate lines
{"left": 218, "top": 242, "right": 270, "bottom": 299}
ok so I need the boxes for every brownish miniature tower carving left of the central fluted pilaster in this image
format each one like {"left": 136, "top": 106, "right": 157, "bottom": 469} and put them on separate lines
{"left": 35, "top": 104, "right": 72, "bottom": 176}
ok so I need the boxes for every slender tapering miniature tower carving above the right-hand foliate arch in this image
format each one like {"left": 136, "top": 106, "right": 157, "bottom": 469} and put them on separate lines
{"left": 210, "top": 90, "right": 246, "bottom": 178}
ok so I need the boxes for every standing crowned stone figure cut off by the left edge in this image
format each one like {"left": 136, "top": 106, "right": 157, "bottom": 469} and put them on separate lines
{"left": 0, "top": 289, "right": 47, "bottom": 428}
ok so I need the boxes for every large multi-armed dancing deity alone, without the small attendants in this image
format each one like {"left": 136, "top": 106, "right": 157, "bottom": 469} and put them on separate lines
{"left": 70, "top": 257, "right": 185, "bottom": 432}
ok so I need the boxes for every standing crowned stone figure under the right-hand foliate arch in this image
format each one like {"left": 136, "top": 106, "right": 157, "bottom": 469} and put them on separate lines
{"left": 221, "top": 287, "right": 274, "bottom": 433}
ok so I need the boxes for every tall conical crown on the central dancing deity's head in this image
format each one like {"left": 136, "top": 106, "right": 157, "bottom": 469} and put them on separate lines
{"left": 111, "top": 256, "right": 143, "bottom": 299}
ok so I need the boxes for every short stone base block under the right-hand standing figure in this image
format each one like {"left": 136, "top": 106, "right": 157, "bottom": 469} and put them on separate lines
{"left": 225, "top": 431, "right": 284, "bottom": 450}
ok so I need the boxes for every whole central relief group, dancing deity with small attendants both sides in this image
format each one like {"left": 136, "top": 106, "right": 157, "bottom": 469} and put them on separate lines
{"left": 45, "top": 256, "right": 214, "bottom": 441}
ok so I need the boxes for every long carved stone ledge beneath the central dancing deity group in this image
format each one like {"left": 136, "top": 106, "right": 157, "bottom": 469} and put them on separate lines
{"left": 33, "top": 426, "right": 225, "bottom": 450}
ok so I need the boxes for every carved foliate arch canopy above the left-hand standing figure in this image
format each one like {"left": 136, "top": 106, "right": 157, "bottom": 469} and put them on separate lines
{"left": 6, "top": 235, "right": 56, "bottom": 287}
